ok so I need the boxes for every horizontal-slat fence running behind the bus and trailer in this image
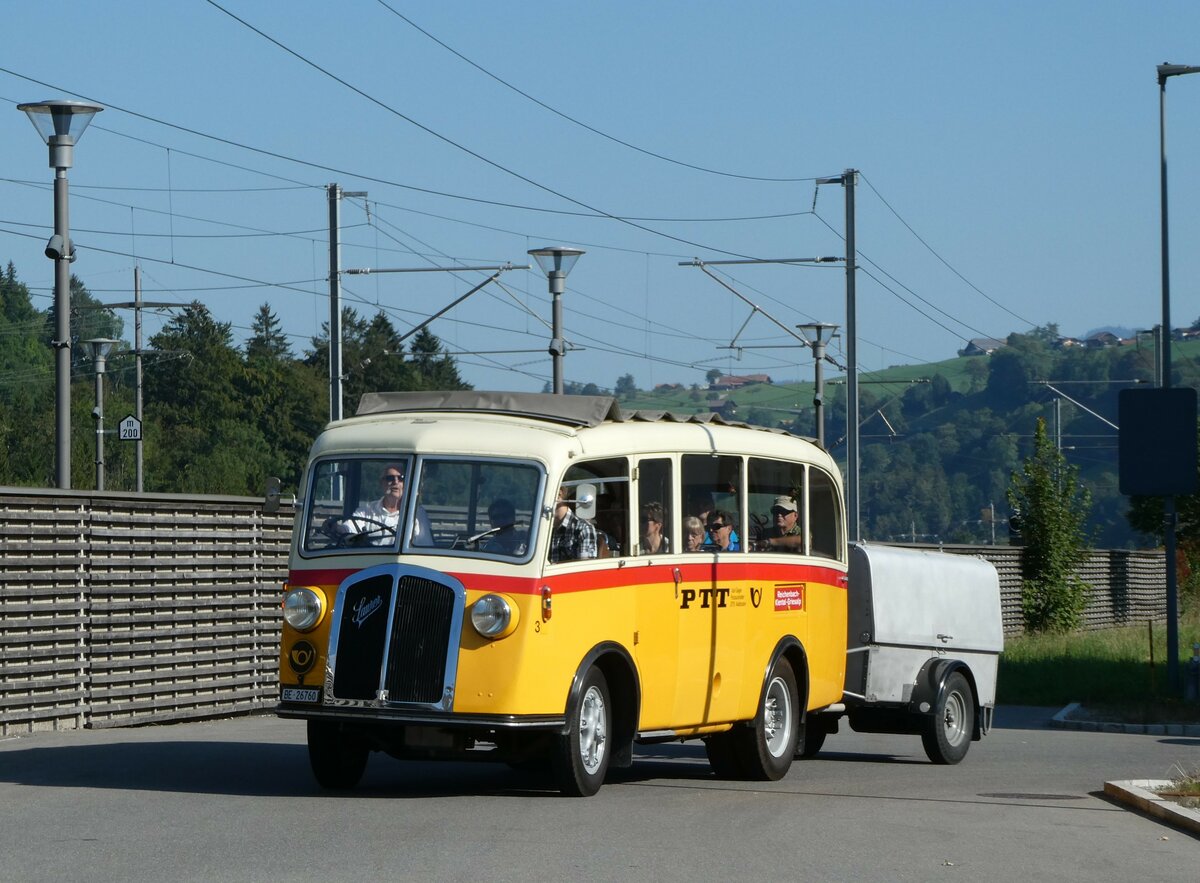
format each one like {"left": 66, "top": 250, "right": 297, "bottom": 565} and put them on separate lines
{"left": 0, "top": 488, "right": 1165, "bottom": 735}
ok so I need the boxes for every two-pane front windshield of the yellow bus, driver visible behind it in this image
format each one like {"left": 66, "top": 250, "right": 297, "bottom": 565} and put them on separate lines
{"left": 302, "top": 455, "right": 544, "bottom": 561}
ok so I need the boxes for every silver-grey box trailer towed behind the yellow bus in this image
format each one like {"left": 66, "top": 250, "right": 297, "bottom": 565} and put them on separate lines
{"left": 797, "top": 543, "right": 1004, "bottom": 763}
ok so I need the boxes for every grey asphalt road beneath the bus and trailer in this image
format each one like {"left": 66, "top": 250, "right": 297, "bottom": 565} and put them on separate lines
{"left": 0, "top": 708, "right": 1200, "bottom": 883}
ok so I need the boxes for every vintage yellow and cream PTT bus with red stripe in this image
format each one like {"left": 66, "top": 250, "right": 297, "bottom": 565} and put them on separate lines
{"left": 277, "top": 391, "right": 848, "bottom": 795}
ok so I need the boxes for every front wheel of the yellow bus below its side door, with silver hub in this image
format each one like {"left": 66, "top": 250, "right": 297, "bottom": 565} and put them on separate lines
{"left": 552, "top": 666, "right": 613, "bottom": 797}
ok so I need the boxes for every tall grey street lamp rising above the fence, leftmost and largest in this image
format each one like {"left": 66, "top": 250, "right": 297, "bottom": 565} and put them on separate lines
{"left": 17, "top": 101, "right": 104, "bottom": 489}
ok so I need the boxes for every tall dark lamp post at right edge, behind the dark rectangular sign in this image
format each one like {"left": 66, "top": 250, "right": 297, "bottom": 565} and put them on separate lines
{"left": 1158, "top": 64, "right": 1200, "bottom": 691}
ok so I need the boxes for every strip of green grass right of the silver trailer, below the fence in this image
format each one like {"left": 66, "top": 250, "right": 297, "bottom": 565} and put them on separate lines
{"left": 996, "top": 614, "right": 1200, "bottom": 723}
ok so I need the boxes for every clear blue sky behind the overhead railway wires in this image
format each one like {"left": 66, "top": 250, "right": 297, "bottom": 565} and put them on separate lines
{"left": 0, "top": 0, "right": 1200, "bottom": 390}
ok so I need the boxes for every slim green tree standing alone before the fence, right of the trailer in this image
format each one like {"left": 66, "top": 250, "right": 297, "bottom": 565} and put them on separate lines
{"left": 1008, "top": 418, "right": 1092, "bottom": 632}
